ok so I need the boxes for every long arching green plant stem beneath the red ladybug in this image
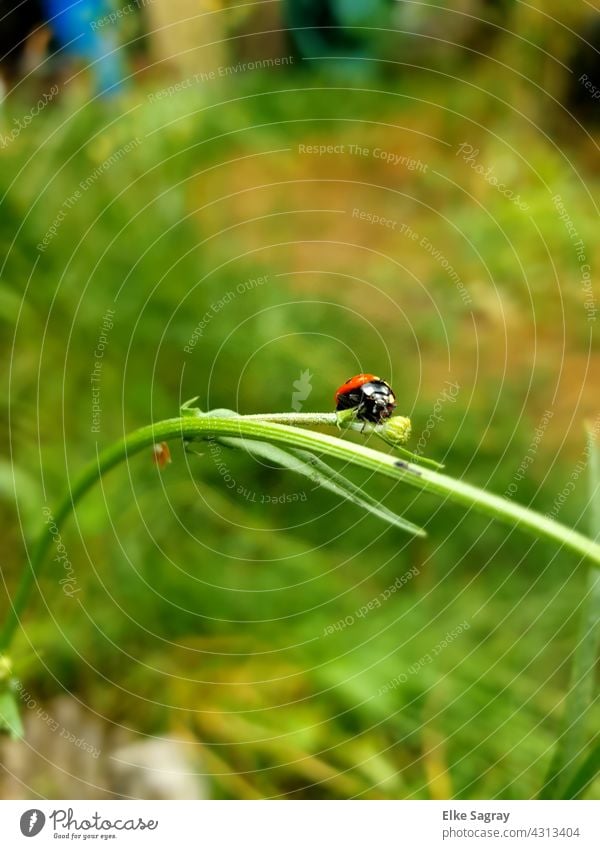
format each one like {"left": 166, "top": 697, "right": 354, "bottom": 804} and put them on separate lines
{"left": 0, "top": 413, "right": 600, "bottom": 653}
